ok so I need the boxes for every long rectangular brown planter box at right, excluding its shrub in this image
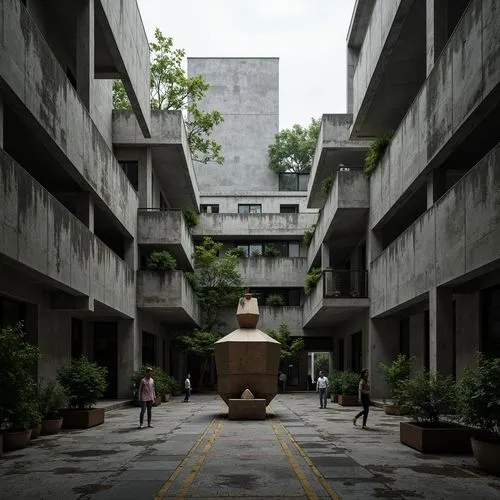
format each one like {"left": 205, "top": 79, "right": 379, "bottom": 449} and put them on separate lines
{"left": 399, "top": 422, "right": 472, "bottom": 454}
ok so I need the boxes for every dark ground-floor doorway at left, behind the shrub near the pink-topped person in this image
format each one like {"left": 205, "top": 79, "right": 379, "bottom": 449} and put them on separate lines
{"left": 94, "top": 321, "right": 118, "bottom": 399}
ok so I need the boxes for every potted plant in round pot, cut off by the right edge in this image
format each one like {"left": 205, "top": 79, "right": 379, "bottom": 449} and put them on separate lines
{"left": 458, "top": 353, "right": 500, "bottom": 476}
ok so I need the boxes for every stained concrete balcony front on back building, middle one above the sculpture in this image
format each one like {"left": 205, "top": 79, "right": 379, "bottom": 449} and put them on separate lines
{"left": 238, "top": 257, "right": 306, "bottom": 288}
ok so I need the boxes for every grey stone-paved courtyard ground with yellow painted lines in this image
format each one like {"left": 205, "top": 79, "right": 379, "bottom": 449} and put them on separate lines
{"left": 0, "top": 393, "right": 500, "bottom": 500}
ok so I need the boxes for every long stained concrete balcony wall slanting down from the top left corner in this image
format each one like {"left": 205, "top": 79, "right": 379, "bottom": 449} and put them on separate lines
{"left": 0, "top": 0, "right": 137, "bottom": 237}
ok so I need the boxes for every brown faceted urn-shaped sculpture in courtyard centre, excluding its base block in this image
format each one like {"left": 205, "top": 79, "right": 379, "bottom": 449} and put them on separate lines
{"left": 215, "top": 293, "right": 281, "bottom": 405}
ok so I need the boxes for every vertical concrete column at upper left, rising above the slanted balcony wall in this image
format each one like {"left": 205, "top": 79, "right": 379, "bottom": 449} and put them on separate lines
{"left": 76, "top": 0, "right": 95, "bottom": 110}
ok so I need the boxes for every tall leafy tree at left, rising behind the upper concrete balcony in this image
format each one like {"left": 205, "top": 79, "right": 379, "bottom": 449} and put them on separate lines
{"left": 113, "top": 28, "right": 224, "bottom": 164}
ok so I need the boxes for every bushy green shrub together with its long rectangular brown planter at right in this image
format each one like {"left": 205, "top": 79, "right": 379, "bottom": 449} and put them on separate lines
{"left": 396, "top": 371, "right": 471, "bottom": 453}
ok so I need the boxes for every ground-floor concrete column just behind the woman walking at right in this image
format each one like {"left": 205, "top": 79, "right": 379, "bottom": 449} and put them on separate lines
{"left": 368, "top": 318, "right": 399, "bottom": 398}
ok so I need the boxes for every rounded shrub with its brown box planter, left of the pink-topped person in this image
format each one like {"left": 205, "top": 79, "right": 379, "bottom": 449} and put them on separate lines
{"left": 57, "top": 356, "right": 108, "bottom": 429}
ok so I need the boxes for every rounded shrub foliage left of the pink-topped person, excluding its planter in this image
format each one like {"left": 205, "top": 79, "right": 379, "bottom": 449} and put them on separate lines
{"left": 57, "top": 356, "right": 108, "bottom": 410}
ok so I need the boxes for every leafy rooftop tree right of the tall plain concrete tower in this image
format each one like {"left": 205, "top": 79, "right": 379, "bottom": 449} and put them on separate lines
{"left": 268, "top": 118, "right": 321, "bottom": 173}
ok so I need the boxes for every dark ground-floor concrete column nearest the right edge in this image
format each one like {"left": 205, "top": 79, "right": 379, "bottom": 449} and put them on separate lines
{"left": 455, "top": 292, "right": 481, "bottom": 379}
